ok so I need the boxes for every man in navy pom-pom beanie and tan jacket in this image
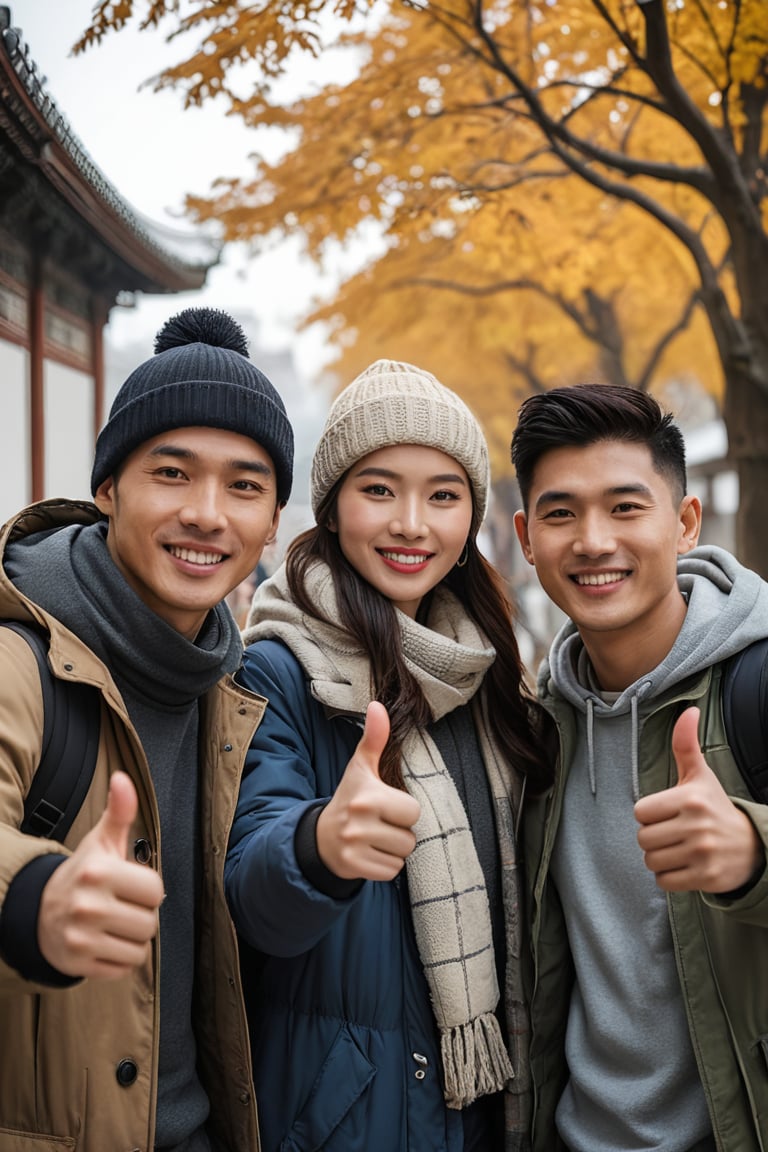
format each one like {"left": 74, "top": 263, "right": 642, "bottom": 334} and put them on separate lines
{"left": 0, "top": 309, "right": 294, "bottom": 1152}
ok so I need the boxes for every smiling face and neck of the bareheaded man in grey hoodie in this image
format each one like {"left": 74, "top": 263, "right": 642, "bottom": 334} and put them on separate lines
{"left": 515, "top": 440, "right": 701, "bottom": 689}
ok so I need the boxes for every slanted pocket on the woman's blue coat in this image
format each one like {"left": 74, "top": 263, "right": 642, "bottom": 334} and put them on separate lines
{"left": 282, "top": 1025, "right": 377, "bottom": 1152}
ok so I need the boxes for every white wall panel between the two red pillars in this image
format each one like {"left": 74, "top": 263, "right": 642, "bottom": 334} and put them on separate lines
{"left": 44, "top": 359, "right": 93, "bottom": 500}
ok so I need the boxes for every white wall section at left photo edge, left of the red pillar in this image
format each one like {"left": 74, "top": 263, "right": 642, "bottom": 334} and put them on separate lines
{"left": 0, "top": 340, "right": 30, "bottom": 523}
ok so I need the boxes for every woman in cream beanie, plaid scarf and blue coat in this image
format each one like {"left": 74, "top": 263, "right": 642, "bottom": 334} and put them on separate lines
{"left": 226, "top": 361, "right": 548, "bottom": 1152}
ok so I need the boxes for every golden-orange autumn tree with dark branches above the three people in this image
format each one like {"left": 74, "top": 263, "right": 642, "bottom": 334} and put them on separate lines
{"left": 76, "top": 0, "right": 768, "bottom": 575}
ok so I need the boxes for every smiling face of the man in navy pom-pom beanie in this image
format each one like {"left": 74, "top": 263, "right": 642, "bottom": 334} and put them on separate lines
{"left": 94, "top": 427, "right": 280, "bottom": 639}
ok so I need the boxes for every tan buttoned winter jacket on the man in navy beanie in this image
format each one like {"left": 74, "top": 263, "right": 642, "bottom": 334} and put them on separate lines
{"left": 0, "top": 500, "right": 266, "bottom": 1152}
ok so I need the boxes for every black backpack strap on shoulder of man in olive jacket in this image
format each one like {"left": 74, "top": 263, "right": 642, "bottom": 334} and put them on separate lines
{"left": 723, "top": 637, "right": 768, "bottom": 804}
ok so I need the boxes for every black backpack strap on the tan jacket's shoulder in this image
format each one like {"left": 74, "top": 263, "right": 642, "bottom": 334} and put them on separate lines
{"left": 2, "top": 621, "right": 101, "bottom": 841}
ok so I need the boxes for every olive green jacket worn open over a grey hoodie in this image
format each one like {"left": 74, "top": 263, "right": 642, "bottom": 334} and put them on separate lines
{"left": 525, "top": 666, "right": 768, "bottom": 1152}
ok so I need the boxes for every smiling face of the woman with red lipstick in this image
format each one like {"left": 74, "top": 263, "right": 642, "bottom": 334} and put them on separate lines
{"left": 329, "top": 445, "right": 472, "bottom": 619}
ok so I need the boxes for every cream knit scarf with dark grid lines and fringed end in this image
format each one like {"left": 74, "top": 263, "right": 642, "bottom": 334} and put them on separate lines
{"left": 243, "top": 561, "right": 530, "bottom": 1152}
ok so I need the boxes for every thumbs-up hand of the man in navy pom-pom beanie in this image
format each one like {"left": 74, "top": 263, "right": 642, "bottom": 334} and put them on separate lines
{"left": 37, "top": 772, "right": 164, "bottom": 980}
